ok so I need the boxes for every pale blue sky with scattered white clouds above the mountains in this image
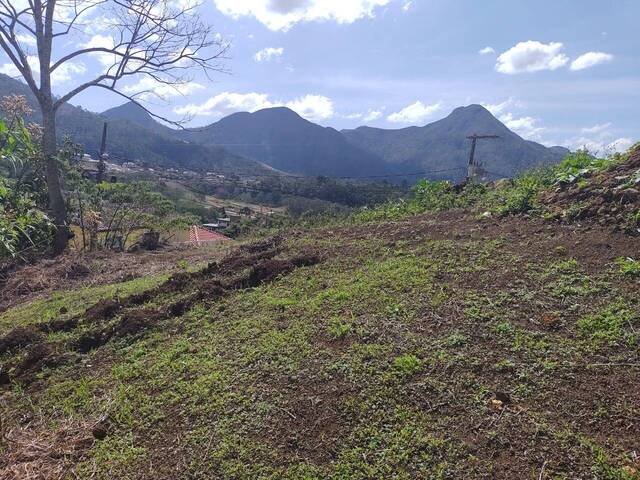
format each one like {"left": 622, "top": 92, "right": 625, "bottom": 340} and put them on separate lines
{"left": 0, "top": 0, "right": 640, "bottom": 153}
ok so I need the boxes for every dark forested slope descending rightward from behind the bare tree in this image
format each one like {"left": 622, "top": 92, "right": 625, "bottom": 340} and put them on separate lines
{"left": 0, "top": 74, "right": 270, "bottom": 173}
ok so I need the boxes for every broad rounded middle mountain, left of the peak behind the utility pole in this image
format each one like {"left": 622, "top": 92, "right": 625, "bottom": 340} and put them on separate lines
{"left": 178, "top": 107, "right": 402, "bottom": 176}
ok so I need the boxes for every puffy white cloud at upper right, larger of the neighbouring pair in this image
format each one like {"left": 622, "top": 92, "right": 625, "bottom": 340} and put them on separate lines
{"left": 496, "top": 40, "right": 569, "bottom": 74}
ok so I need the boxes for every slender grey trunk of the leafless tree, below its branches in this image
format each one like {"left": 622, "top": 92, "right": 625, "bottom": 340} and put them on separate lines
{"left": 40, "top": 102, "right": 69, "bottom": 255}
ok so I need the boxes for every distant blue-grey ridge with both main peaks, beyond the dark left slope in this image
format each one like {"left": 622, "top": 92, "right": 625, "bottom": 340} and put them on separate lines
{"left": 105, "top": 104, "right": 569, "bottom": 181}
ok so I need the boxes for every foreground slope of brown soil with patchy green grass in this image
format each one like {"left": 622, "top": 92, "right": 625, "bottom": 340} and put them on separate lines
{"left": 0, "top": 180, "right": 640, "bottom": 480}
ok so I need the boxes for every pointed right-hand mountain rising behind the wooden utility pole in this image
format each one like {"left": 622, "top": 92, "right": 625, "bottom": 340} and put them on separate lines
{"left": 342, "top": 105, "right": 569, "bottom": 180}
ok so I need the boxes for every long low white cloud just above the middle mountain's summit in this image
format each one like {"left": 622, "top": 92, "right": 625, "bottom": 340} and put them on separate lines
{"left": 174, "top": 92, "right": 334, "bottom": 121}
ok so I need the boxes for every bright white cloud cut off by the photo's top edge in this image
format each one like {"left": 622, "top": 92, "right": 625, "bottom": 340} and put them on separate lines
{"left": 213, "top": 0, "right": 391, "bottom": 30}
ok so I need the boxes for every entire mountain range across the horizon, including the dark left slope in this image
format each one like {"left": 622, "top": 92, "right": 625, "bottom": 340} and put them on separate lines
{"left": 0, "top": 75, "right": 568, "bottom": 181}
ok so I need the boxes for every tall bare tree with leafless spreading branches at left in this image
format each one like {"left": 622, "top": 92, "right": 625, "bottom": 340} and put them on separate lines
{"left": 0, "top": 0, "right": 227, "bottom": 253}
